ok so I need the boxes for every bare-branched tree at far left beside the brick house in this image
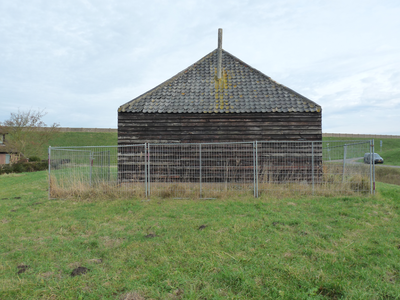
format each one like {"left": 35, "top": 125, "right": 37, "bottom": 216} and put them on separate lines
{"left": 0, "top": 109, "right": 60, "bottom": 158}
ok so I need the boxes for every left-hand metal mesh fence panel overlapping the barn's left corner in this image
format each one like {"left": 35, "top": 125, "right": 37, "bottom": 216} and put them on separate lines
{"left": 49, "top": 145, "right": 146, "bottom": 198}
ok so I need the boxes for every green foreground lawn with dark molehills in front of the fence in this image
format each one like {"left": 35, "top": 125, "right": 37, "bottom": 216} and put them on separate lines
{"left": 0, "top": 172, "right": 400, "bottom": 299}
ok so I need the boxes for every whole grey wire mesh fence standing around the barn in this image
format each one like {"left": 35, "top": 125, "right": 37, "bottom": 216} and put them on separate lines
{"left": 49, "top": 141, "right": 374, "bottom": 198}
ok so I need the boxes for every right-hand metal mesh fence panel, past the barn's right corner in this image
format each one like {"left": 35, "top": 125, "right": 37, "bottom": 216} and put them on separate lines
{"left": 257, "top": 141, "right": 371, "bottom": 195}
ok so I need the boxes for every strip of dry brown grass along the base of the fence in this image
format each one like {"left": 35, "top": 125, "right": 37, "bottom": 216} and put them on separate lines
{"left": 50, "top": 164, "right": 370, "bottom": 199}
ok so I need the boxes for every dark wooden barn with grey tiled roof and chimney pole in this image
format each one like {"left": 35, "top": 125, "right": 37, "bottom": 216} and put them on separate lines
{"left": 118, "top": 29, "right": 322, "bottom": 182}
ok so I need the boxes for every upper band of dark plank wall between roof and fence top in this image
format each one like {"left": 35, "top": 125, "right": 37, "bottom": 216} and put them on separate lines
{"left": 118, "top": 112, "right": 322, "bottom": 145}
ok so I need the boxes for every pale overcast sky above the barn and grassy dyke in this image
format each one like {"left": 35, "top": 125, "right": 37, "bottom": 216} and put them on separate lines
{"left": 0, "top": 0, "right": 400, "bottom": 135}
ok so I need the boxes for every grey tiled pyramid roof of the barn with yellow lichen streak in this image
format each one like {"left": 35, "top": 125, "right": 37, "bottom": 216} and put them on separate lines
{"left": 118, "top": 49, "right": 321, "bottom": 113}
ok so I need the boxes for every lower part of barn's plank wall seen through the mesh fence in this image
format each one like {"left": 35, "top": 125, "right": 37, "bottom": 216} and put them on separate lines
{"left": 118, "top": 141, "right": 322, "bottom": 183}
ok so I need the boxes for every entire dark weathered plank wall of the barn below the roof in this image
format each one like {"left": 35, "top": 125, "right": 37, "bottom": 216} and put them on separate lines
{"left": 118, "top": 112, "right": 322, "bottom": 183}
